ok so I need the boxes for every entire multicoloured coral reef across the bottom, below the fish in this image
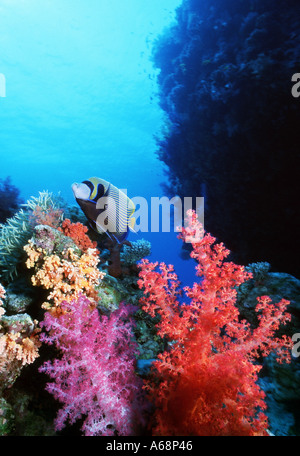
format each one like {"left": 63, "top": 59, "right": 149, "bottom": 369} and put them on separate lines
{"left": 0, "top": 187, "right": 299, "bottom": 436}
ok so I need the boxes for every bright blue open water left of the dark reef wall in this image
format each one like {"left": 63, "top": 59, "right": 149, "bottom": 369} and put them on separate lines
{"left": 0, "top": 0, "right": 194, "bottom": 283}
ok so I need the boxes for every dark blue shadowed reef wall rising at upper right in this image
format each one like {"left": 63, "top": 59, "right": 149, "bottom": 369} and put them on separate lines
{"left": 153, "top": 0, "right": 300, "bottom": 275}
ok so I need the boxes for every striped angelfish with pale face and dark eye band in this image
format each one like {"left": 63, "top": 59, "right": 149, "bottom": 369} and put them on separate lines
{"left": 72, "top": 177, "right": 135, "bottom": 244}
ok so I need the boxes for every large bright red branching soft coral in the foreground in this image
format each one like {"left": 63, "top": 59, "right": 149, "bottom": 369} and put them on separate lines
{"left": 139, "top": 211, "right": 291, "bottom": 435}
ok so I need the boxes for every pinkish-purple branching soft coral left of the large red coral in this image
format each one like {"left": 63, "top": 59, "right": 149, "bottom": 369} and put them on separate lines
{"left": 40, "top": 295, "right": 149, "bottom": 435}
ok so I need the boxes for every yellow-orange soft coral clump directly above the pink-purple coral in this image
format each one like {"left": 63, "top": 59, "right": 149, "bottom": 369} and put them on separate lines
{"left": 24, "top": 241, "right": 104, "bottom": 313}
